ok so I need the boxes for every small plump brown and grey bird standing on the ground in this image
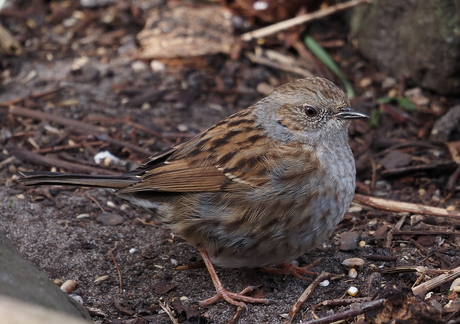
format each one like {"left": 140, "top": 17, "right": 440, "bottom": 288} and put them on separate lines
{"left": 20, "top": 78, "right": 367, "bottom": 306}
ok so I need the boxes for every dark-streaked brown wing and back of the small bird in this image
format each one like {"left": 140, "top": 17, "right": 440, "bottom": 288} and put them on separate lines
{"left": 118, "top": 108, "right": 308, "bottom": 194}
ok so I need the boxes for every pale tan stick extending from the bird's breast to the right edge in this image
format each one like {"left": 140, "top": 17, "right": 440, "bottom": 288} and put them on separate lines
{"left": 354, "top": 194, "right": 460, "bottom": 219}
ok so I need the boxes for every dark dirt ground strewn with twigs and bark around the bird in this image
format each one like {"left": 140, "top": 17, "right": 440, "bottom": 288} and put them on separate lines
{"left": 0, "top": 1, "right": 460, "bottom": 323}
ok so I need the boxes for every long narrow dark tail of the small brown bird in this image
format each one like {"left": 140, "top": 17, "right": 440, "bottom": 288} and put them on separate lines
{"left": 19, "top": 172, "right": 140, "bottom": 189}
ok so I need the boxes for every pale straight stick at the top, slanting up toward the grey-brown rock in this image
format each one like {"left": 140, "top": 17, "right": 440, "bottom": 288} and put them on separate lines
{"left": 241, "top": 0, "right": 371, "bottom": 42}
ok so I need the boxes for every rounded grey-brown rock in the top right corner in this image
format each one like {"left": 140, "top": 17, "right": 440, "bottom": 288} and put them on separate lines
{"left": 351, "top": 0, "right": 460, "bottom": 94}
